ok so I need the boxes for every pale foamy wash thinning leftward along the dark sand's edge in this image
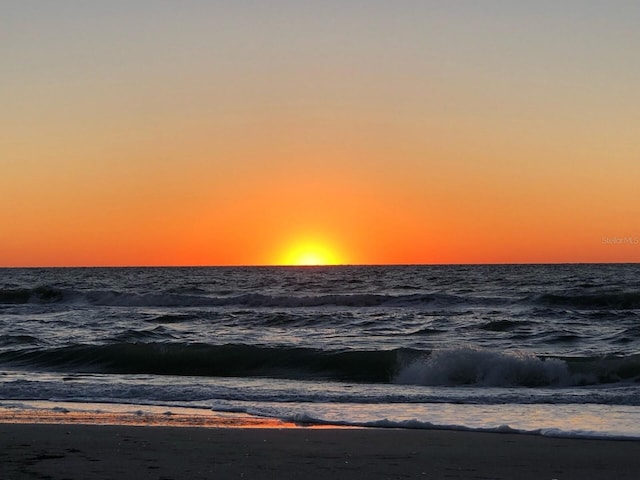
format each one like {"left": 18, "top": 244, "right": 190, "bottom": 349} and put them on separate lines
{"left": 223, "top": 402, "right": 640, "bottom": 440}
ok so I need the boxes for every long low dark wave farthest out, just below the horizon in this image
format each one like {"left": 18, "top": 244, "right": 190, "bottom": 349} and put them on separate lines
{"left": 5, "top": 285, "right": 640, "bottom": 312}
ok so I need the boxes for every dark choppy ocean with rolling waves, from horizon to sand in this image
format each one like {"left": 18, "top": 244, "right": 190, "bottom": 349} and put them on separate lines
{"left": 0, "top": 264, "right": 640, "bottom": 439}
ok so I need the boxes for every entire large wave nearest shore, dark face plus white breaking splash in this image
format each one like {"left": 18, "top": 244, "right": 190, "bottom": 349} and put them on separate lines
{"left": 5, "top": 344, "right": 640, "bottom": 387}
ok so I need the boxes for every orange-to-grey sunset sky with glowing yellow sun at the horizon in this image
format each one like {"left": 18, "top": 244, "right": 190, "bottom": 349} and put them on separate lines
{"left": 0, "top": 0, "right": 640, "bottom": 266}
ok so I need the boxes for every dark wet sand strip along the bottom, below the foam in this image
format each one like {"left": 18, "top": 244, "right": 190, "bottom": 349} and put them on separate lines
{"left": 0, "top": 424, "right": 640, "bottom": 480}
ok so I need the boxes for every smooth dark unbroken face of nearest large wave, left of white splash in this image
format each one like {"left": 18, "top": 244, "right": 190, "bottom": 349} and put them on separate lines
{"left": 0, "top": 343, "right": 396, "bottom": 382}
